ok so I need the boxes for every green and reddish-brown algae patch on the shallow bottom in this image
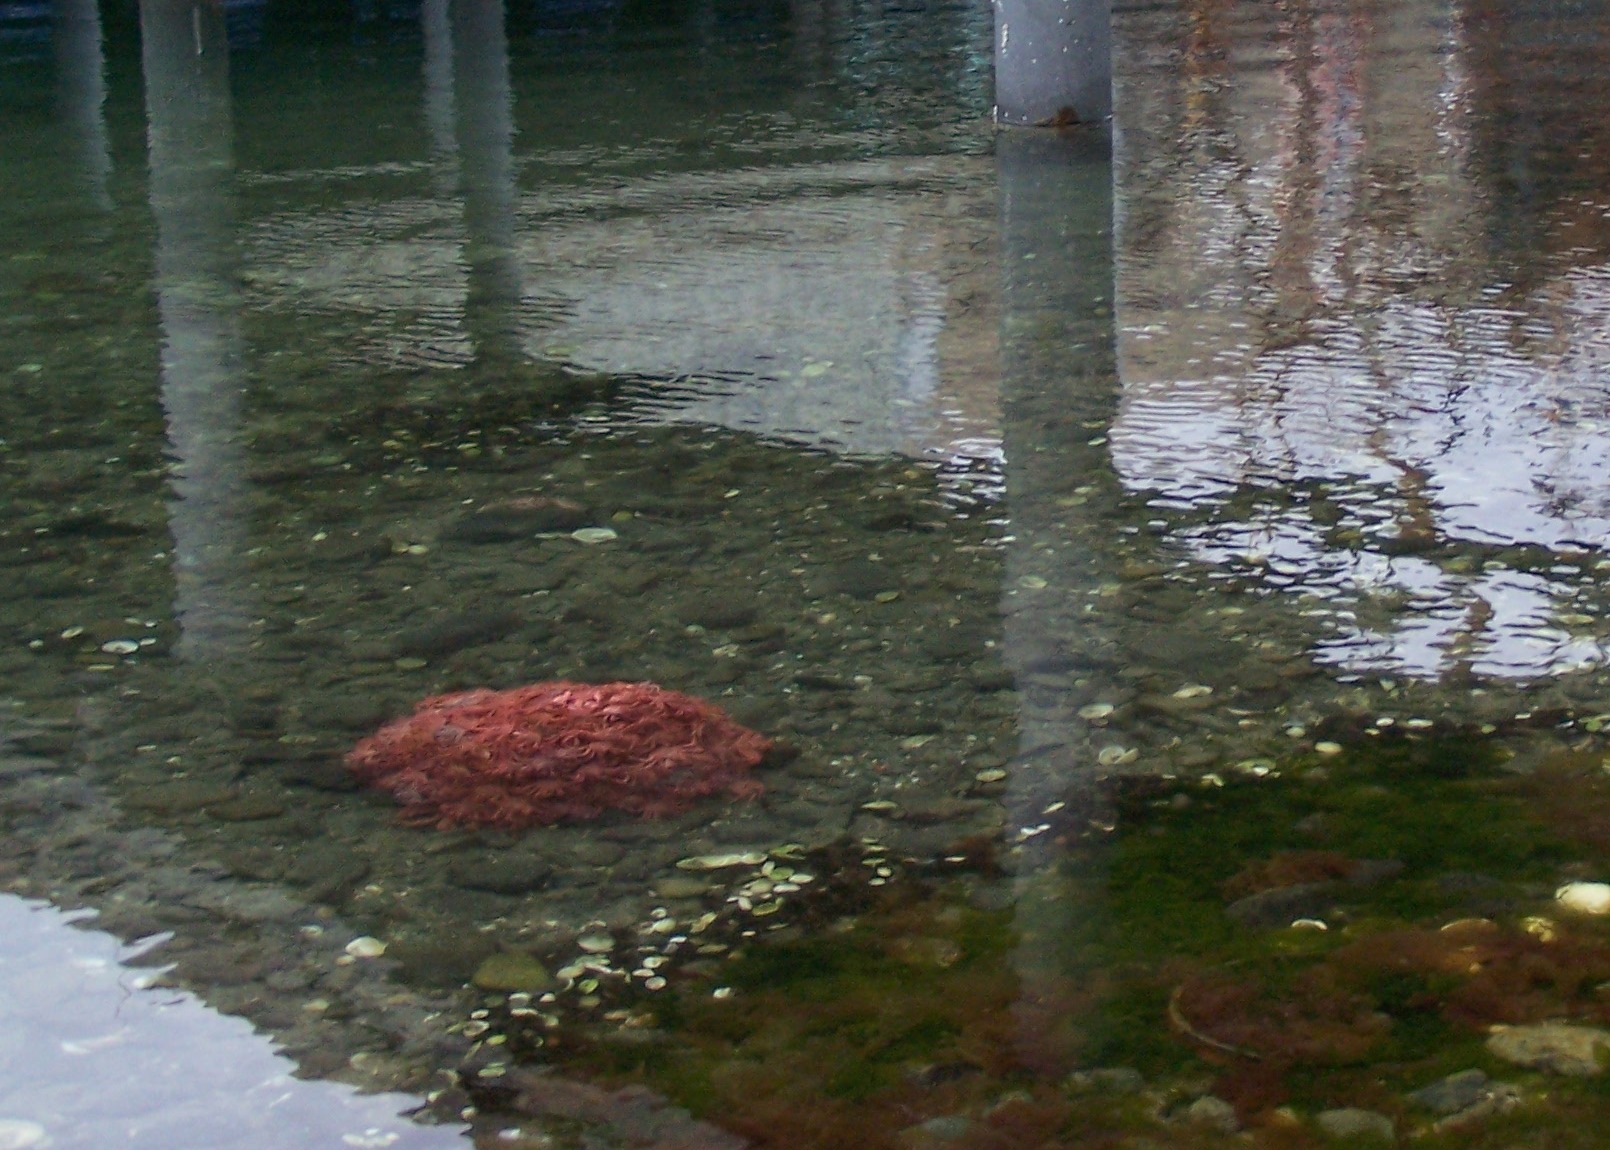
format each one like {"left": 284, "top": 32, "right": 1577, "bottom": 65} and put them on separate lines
{"left": 511, "top": 736, "right": 1610, "bottom": 1150}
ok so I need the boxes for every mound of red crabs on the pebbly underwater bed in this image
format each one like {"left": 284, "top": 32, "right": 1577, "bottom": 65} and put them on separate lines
{"left": 346, "top": 681, "right": 771, "bottom": 828}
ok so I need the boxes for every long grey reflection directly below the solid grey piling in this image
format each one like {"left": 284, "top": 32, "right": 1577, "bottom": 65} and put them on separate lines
{"left": 995, "top": 127, "right": 1137, "bottom": 1066}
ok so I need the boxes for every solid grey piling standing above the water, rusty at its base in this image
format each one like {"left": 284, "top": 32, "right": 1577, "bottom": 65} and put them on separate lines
{"left": 993, "top": 0, "right": 1113, "bottom": 127}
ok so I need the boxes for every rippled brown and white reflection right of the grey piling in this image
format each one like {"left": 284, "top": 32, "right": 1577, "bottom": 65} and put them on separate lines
{"left": 1113, "top": 5, "right": 1610, "bottom": 678}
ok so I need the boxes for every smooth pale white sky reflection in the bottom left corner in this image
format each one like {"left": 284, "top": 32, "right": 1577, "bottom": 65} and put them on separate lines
{"left": 0, "top": 896, "right": 464, "bottom": 1150}
